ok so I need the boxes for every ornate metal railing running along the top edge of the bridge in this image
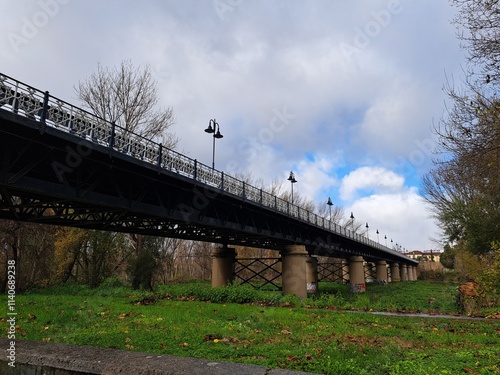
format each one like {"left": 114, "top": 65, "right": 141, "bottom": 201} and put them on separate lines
{"left": 0, "top": 74, "right": 397, "bottom": 253}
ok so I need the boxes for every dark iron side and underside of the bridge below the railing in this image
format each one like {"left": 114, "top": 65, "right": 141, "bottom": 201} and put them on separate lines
{"left": 0, "top": 110, "right": 414, "bottom": 261}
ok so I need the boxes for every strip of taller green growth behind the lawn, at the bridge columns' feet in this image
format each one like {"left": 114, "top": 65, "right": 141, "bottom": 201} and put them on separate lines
{"left": 24, "top": 280, "right": 459, "bottom": 314}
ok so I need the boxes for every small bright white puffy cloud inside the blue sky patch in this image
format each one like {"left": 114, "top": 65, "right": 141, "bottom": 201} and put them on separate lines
{"left": 340, "top": 167, "right": 404, "bottom": 201}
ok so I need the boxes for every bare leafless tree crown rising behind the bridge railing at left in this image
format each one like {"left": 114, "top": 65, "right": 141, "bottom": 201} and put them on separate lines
{"left": 75, "top": 61, "right": 178, "bottom": 149}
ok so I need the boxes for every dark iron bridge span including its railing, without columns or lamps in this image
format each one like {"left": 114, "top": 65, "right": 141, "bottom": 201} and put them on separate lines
{"left": 0, "top": 74, "right": 418, "bottom": 265}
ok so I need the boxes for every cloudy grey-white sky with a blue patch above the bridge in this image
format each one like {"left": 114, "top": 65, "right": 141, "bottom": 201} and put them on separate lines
{"left": 0, "top": 0, "right": 466, "bottom": 251}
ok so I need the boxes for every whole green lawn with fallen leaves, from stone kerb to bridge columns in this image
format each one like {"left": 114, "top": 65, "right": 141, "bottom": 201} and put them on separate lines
{"left": 0, "top": 281, "right": 500, "bottom": 375}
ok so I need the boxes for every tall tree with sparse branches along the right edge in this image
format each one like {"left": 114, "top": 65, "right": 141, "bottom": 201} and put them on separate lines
{"left": 423, "top": 0, "right": 500, "bottom": 254}
